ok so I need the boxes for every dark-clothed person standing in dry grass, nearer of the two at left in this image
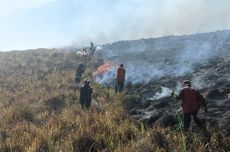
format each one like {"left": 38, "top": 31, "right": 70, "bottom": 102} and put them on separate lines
{"left": 80, "top": 78, "right": 93, "bottom": 109}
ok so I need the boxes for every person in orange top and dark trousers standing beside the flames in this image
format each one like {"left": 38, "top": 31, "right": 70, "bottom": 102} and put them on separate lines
{"left": 115, "top": 64, "right": 125, "bottom": 93}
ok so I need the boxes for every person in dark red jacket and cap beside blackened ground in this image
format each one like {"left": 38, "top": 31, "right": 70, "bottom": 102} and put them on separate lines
{"left": 173, "top": 80, "right": 207, "bottom": 132}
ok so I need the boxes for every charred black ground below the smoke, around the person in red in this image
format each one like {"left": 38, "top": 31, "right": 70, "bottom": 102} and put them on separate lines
{"left": 126, "top": 55, "right": 230, "bottom": 132}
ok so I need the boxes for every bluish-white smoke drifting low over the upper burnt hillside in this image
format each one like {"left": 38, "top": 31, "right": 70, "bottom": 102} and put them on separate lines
{"left": 96, "top": 31, "right": 230, "bottom": 85}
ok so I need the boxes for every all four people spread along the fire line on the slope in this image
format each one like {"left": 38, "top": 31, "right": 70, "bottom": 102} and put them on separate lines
{"left": 75, "top": 64, "right": 207, "bottom": 132}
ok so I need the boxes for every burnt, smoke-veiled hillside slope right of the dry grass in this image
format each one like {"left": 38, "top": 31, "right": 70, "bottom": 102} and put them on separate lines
{"left": 95, "top": 31, "right": 230, "bottom": 131}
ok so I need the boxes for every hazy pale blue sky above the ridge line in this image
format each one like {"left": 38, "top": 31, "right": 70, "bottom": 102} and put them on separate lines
{"left": 0, "top": 0, "right": 230, "bottom": 51}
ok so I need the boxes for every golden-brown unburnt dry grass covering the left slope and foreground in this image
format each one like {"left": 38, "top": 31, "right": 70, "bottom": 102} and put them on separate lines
{"left": 0, "top": 51, "right": 230, "bottom": 152}
